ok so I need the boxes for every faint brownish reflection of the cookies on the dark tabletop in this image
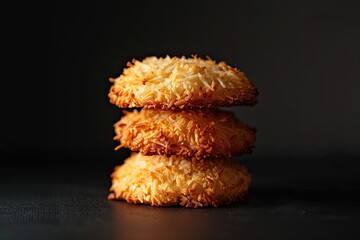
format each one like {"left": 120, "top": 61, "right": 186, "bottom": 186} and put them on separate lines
{"left": 110, "top": 202, "right": 218, "bottom": 239}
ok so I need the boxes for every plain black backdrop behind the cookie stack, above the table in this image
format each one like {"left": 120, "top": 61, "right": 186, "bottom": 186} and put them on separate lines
{"left": 0, "top": 0, "right": 360, "bottom": 239}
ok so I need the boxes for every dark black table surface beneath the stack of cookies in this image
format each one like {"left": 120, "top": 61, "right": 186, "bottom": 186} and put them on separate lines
{"left": 0, "top": 156, "right": 360, "bottom": 239}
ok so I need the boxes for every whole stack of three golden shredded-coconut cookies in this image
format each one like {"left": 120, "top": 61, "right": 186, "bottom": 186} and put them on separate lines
{"left": 108, "top": 56, "right": 258, "bottom": 208}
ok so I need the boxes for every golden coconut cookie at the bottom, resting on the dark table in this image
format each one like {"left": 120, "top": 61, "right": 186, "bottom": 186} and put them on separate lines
{"left": 108, "top": 153, "right": 250, "bottom": 208}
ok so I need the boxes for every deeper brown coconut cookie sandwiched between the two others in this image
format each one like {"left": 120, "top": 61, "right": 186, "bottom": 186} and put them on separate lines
{"left": 114, "top": 108, "right": 256, "bottom": 158}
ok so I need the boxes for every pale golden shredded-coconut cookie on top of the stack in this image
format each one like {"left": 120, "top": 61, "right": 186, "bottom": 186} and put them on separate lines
{"left": 108, "top": 56, "right": 258, "bottom": 109}
